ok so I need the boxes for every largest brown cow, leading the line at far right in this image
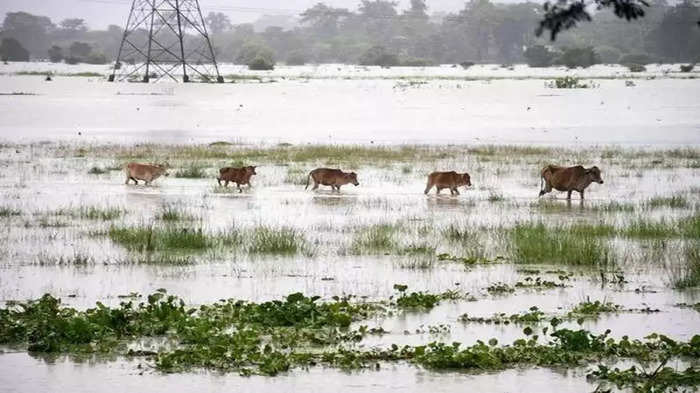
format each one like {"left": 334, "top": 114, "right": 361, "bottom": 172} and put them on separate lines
{"left": 540, "top": 165, "right": 603, "bottom": 199}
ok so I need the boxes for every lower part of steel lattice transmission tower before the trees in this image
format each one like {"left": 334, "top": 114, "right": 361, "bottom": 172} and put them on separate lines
{"left": 109, "top": 0, "right": 224, "bottom": 83}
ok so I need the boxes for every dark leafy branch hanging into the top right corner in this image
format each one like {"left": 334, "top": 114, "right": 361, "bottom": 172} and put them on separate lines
{"left": 535, "top": 0, "right": 652, "bottom": 41}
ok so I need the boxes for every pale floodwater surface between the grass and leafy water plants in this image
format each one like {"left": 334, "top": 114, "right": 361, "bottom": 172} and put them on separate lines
{"left": 0, "top": 66, "right": 700, "bottom": 392}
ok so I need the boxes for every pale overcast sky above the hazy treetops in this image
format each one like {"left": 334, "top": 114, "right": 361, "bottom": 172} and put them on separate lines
{"left": 0, "top": 0, "right": 513, "bottom": 29}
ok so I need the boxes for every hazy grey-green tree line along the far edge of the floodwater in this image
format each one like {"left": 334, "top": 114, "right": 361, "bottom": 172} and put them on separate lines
{"left": 0, "top": 0, "right": 700, "bottom": 69}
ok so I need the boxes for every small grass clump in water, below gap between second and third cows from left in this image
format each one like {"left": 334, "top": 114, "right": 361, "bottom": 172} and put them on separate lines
{"left": 248, "top": 226, "right": 308, "bottom": 255}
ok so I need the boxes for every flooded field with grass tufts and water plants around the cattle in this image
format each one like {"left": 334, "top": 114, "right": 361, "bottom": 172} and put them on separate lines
{"left": 0, "top": 64, "right": 700, "bottom": 392}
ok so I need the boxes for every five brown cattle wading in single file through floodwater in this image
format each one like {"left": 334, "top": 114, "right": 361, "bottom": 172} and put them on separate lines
{"left": 125, "top": 162, "right": 603, "bottom": 199}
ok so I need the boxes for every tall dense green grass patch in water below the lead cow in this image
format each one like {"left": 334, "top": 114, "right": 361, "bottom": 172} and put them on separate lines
{"left": 511, "top": 223, "right": 614, "bottom": 266}
